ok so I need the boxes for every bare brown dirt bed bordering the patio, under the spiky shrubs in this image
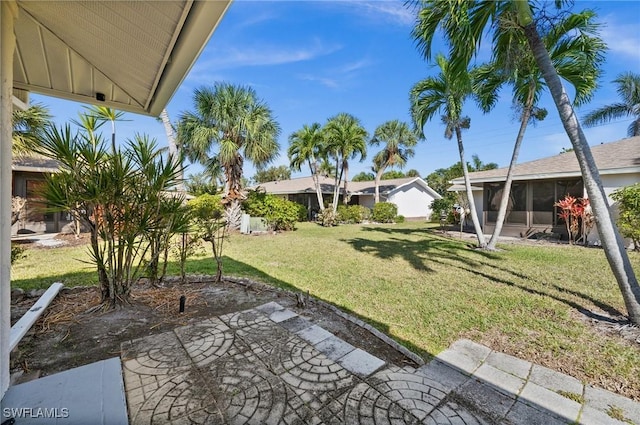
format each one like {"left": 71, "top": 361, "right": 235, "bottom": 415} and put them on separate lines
{"left": 11, "top": 277, "right": 416, "bottom": 383}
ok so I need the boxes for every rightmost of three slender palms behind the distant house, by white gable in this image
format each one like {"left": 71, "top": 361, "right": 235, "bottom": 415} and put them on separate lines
{"left": 370, "top": 120, "right": 418, "bottom": 203}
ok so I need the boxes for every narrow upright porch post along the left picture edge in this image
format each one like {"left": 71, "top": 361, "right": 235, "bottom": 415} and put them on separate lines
{"left": 0, "top": 0, "right": 18, "bottom": 399}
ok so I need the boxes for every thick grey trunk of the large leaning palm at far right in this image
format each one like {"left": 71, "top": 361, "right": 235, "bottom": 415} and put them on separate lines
{"left": 524, "top": 24, "right": 640, "bottom": 325}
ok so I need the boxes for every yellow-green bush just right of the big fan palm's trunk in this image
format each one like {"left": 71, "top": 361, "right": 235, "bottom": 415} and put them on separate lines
{"left": 242, "top": 190, "right": 307, "bottom": 230}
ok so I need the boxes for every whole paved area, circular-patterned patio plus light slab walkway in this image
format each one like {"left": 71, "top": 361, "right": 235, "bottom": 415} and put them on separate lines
{"left": 122, "top": 302, "right": 640, "bottom": 425}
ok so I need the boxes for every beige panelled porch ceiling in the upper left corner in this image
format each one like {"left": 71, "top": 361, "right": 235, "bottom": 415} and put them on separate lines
{"left": 13, "top": 0, "right": 231, "bottom": 116}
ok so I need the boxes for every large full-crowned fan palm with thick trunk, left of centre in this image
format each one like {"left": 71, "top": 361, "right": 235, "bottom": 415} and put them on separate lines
{"left": 178, "top": 83, "right": 280, "bottom": 229}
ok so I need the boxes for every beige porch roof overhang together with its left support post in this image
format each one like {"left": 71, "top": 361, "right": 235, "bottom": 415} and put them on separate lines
{"left": 0, "top": 0, "right": 230, "bottom": 397}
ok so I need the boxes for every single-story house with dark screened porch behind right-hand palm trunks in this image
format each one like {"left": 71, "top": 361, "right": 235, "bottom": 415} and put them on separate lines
{"left": 452, "top": 137, "right": 640, "bottom": 243}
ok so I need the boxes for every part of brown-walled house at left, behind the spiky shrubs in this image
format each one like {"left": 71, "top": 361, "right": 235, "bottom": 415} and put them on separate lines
{"left": 11, "top": 156, "right": 71, "bottom": 235}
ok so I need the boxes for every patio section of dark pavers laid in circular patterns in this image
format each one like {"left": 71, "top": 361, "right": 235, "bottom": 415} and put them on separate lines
{"left": 122, "top": 303, "right": 490, "bottom": 425}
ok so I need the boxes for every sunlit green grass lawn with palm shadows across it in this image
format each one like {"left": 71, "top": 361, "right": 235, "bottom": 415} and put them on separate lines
{"left": 12, "top": 222, "right": 640, "bottom": 400}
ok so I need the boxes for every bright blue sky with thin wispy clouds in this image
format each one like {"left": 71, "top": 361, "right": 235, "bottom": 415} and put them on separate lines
{"left": 32, "top": 0, "right": 640, "bottom": 177}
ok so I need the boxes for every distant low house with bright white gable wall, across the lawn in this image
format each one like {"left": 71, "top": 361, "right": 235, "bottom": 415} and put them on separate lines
{"left": 256, "top": 176, "right": 441, "bottom": 219}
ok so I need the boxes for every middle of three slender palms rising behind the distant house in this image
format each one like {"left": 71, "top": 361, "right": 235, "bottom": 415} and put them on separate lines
{"left": 323, "top": 112, "right": 368, "bottom": 212}
